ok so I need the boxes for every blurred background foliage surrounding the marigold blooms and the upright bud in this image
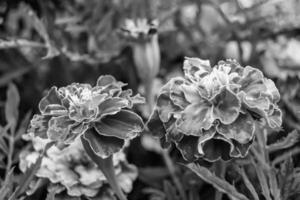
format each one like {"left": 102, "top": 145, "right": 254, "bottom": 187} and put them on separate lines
{"left": 0, "top": 0, "right": 300, "bottom": 200}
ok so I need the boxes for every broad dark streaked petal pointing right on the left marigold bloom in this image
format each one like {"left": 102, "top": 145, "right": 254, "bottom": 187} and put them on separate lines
{"left": 94, "top": 110, "right": 144, "bottom": 139}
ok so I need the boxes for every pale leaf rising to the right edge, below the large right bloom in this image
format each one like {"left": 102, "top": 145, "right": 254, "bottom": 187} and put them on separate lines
{"left": 267, "top": 130, "right": 300, "bottom": 153}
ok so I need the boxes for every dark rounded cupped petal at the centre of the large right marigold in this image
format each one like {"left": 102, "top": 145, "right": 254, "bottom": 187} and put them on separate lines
{"left": 213, "top": 87, "right": 241, "bottom": 124}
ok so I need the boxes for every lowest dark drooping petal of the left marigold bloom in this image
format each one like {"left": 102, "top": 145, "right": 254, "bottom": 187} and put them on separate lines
{"left": 83, "top": 128, "right": 125, "bottom": 158}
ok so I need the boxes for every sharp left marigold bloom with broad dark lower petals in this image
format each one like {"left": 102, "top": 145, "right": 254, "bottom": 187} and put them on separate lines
{"left": 29, "top": 75, "right": 144, "bottom": 158}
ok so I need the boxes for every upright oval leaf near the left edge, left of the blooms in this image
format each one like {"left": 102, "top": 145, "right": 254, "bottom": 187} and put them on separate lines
{"left": 5, "top": 83, "right": 20, "bottom": 133}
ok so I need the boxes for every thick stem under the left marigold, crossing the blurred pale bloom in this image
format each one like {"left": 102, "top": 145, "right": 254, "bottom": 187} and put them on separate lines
{"left": 81, "top": 137, "right": 127, "bottom": 200}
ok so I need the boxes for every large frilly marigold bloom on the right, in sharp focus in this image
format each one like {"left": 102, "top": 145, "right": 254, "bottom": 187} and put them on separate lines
{"left": 147, "top": 58, "right": 282, "bottom": 161}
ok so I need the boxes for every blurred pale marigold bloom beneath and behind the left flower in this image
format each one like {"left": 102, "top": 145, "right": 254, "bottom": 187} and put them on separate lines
{"left": 19, "top": 135, "right": 137, "bottom": 200}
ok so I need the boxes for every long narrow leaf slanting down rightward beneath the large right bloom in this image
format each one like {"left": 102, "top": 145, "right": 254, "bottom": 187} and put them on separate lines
{"left": 185, "top": 163, "right": 249, "bottom": 200}
